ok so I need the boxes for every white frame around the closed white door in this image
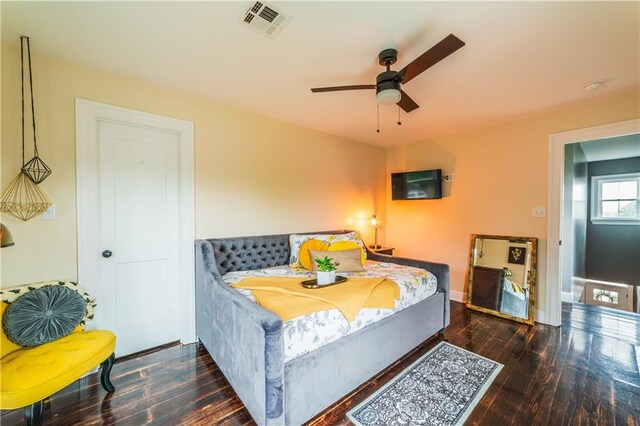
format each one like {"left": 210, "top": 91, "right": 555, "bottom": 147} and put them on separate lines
{"left": 76, "top": 98, "right": 196, "bottom": 344}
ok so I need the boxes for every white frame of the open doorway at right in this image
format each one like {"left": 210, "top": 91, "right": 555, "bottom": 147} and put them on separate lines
{"left": 544, "top": 119, "right": 640, "bottom": 326}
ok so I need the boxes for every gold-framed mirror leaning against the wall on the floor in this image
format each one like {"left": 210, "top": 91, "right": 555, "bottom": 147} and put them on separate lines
{"left": 466, "top": 235, "right": 538, "bottom": 324}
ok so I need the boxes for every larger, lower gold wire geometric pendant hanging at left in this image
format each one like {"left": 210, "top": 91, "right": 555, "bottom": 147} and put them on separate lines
{"left": 0, "top": 172, "right": 51, "bottom": 222}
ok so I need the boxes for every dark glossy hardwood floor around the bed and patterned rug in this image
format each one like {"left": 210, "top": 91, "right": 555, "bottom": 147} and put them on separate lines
{"left": 0, "top": 302, "right": 640, "bottom": 426}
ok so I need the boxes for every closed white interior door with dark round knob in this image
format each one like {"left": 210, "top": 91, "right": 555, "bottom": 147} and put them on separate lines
{"left": 95, "top": 121, "right": 180, "bottom": 356}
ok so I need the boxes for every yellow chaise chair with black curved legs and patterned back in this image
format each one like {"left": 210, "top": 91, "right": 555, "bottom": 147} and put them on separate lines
{"left": 0, "top": 281, "right": 116, "bottom": 425}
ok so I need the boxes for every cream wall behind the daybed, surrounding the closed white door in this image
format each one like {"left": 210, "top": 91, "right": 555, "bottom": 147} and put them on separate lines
{"left": 0, "top": 45, "right": 385, "bottom": 287}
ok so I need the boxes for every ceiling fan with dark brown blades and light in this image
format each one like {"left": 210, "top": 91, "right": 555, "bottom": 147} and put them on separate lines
{"left": 311, "top": 34, "right": 465, "bottom": 112}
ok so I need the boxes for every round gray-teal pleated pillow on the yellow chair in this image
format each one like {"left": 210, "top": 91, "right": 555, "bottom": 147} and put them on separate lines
{"left": 2, "top": 285, "right": 87, "bottom": 346}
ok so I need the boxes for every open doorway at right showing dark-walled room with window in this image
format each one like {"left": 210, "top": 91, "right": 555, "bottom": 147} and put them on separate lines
{"left": 560, "top": 133, "right": 640, "bottom": 313}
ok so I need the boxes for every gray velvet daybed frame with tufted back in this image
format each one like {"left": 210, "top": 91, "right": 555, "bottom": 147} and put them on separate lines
{"left": 195, "top": 230, "right": 449, "bottom": 425}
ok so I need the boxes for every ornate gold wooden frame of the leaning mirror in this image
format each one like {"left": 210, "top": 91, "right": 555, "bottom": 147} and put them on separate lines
{"left": 465, "top": 234, "right": 538, "bottom": 325}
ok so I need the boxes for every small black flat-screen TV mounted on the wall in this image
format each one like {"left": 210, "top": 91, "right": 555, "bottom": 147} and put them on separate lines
{"left": 391, "top": 169, "right": 442, "bottom": 200}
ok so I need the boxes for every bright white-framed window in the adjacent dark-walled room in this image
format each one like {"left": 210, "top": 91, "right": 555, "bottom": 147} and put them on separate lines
{"left": 591, "top": 173, "right": 640, "bottom": 225}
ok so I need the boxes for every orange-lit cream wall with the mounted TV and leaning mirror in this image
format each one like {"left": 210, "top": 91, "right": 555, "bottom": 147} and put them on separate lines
{"left": 385, "top": 89, "right": 640, "bottom": 311}
